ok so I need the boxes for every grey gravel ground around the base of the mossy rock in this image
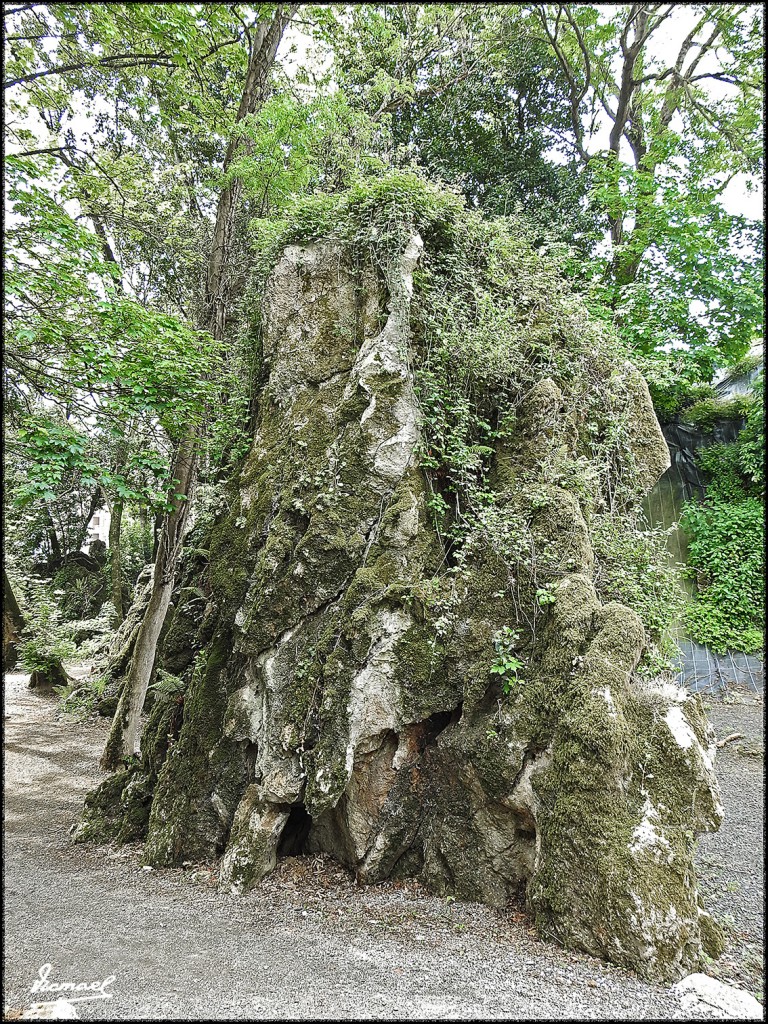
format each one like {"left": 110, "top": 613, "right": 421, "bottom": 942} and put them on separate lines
{"left": 3, "top": 675, "right": 763, "bottom": 1020}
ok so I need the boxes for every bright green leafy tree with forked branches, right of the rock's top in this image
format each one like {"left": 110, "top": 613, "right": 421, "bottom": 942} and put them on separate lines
{"left": 535, "top": 4, "right": 763, "bottom": 372}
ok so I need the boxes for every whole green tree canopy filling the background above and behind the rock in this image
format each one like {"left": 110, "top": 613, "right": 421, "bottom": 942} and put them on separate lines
{"left": 3, "top": 3, "right": 763, "bottom": 655}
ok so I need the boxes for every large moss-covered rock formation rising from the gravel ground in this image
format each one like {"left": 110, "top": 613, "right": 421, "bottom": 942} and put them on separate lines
{"left": 79, "top": 209, "right": 722, "bottom": 978}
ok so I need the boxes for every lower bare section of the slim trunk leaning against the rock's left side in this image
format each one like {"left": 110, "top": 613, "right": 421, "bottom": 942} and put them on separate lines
{"left": 101, "top": 435, "right": 197, "bottom": 769}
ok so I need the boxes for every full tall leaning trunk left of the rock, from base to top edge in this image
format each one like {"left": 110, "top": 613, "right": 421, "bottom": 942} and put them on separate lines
{"left": 101, "top": 5, "right": 298, "bottom": 769}
